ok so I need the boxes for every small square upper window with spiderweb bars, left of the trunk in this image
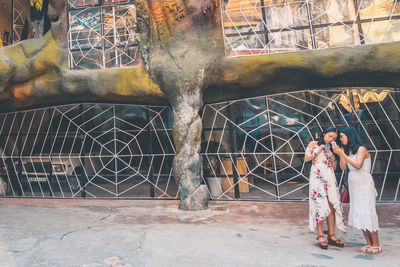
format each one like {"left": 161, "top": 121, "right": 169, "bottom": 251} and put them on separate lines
{"left": 68, "top": 0, "right": 139, "bottom": 70}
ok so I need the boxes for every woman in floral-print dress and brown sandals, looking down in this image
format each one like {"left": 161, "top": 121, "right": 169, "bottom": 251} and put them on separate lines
{"left": 304, "top": 127, "right": 345, "bottom": 249}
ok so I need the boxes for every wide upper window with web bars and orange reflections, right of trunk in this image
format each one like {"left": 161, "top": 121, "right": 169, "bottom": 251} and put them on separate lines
{"left": 221, "top": 0, "right": 400, "bottom": 56}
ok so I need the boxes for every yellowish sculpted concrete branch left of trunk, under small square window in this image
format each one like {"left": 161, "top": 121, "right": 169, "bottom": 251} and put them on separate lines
{"left": 0, "top": 1, "right": 168, "bottom": 110}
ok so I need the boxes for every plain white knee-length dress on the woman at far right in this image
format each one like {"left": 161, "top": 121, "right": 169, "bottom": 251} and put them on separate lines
{"left": 347, "top": 155, "right": 379, "bottom": 232}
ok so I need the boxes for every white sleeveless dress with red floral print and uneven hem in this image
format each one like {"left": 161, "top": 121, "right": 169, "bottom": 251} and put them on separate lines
{"left": 306, "top": 147, "right": 346, "bottom": 232}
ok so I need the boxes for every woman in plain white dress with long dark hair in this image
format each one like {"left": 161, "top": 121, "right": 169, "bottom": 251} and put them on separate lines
{"left": 333, "top": 126, "right": 382, "bottom": 254}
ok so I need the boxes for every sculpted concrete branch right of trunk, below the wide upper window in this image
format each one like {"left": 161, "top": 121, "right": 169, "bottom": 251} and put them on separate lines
{"left": 204, "top": 42, "right": 400, "bottom": 103}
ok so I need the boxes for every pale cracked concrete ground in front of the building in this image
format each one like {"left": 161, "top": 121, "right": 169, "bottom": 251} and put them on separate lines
{"left": 0, "top": 199, "right": 400, "bottom": 267}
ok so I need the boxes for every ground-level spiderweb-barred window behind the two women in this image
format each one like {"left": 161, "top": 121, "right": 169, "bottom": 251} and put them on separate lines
{"left": 202, "top": 89, "right": 400, "bottom": 202}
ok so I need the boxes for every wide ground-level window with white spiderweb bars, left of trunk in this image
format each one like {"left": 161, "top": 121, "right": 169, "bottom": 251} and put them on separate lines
{"left": 0, "top": 104, "right": 177, "bottom": 199}
